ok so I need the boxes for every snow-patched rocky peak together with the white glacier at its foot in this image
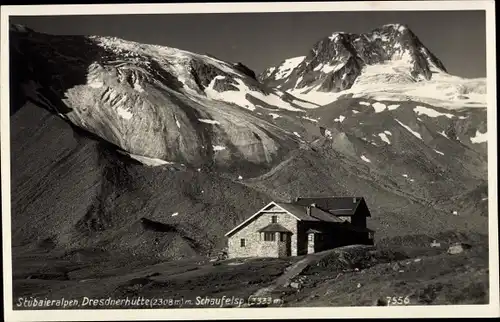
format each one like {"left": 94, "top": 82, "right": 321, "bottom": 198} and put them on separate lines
{"left": 259, "top": 24, "right": 486, "bottom": 107}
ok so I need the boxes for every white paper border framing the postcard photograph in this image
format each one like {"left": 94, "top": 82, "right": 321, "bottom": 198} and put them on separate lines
{"left": 0, "top": 0, "right": 500, "bottom": 321}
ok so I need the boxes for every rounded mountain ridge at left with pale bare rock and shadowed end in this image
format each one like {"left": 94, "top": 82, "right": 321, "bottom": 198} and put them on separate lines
{"left": 11, "top": 24, "right": 320, "bottom": 171}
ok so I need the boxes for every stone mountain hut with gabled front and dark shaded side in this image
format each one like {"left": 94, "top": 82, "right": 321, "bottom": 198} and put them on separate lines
{"left": 226, "top": 197, "right": 374, "bottom": 258}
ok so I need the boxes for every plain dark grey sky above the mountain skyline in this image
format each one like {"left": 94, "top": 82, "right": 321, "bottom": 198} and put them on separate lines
{"left": 11, "top": 11, "right": 486, "bottom": 78}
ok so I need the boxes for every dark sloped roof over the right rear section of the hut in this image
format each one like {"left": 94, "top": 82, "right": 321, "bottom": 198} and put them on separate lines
{"left": 295, "top": 197, "right": 364, "bottom": 216}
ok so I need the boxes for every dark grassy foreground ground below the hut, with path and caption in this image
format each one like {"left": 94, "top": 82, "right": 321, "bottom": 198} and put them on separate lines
{"left": 14, "top": 233, "right": 488, "bottom": 308}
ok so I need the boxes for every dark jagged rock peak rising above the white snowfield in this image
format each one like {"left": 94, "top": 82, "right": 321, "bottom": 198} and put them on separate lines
{"left": 259, "top": 24, "right": 446, "bottom": 92}
